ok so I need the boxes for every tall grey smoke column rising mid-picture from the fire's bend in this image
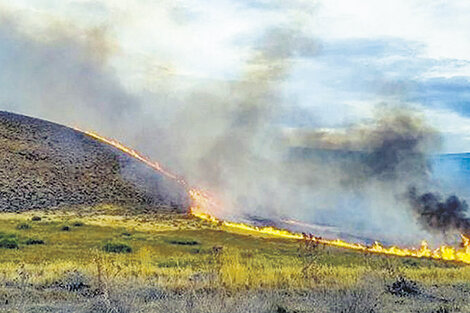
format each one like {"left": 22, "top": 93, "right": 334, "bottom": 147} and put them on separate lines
{"left": 178, "top": 27, "right": 317, "bottom": 207}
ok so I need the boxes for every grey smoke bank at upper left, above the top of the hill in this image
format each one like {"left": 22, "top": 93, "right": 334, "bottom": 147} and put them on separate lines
{"left": 0, "top": 7, "right": 140, "bottom": 133}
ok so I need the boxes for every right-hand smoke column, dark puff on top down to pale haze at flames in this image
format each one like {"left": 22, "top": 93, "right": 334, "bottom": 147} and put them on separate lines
{"left": 285, "top": 104, "right": 440, "bottom": 242}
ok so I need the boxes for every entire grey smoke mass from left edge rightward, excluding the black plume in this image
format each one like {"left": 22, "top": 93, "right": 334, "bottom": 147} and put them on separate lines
{"left": 0, "top": 3, "right": 465, "bottom": 245}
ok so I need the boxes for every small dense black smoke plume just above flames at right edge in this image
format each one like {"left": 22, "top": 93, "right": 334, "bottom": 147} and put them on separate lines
{"left": 408, "top": 187, "right": 470, "bottom": 235}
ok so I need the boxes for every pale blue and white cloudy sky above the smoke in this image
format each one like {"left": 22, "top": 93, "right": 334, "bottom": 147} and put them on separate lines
{"left": 0, "top": 0, "right": 470, "bottom": 153}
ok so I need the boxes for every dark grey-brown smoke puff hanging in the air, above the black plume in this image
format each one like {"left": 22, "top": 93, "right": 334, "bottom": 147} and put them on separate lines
{"left": 286, "top": 105, "right": 440, "bottom": 181}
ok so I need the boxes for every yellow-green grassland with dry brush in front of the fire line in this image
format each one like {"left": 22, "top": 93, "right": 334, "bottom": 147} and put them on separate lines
{"left": 0, "top": 206, "right": 470, "bottom": 313}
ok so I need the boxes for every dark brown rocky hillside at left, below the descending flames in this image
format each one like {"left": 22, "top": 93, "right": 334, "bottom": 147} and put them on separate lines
{"left": 0, "top": 111, "right": 187, "bottom": 211}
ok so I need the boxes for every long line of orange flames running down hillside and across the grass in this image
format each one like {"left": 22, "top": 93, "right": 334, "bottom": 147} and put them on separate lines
{"left": 76, "top": 129, "right": 470, "bottom": 264}
